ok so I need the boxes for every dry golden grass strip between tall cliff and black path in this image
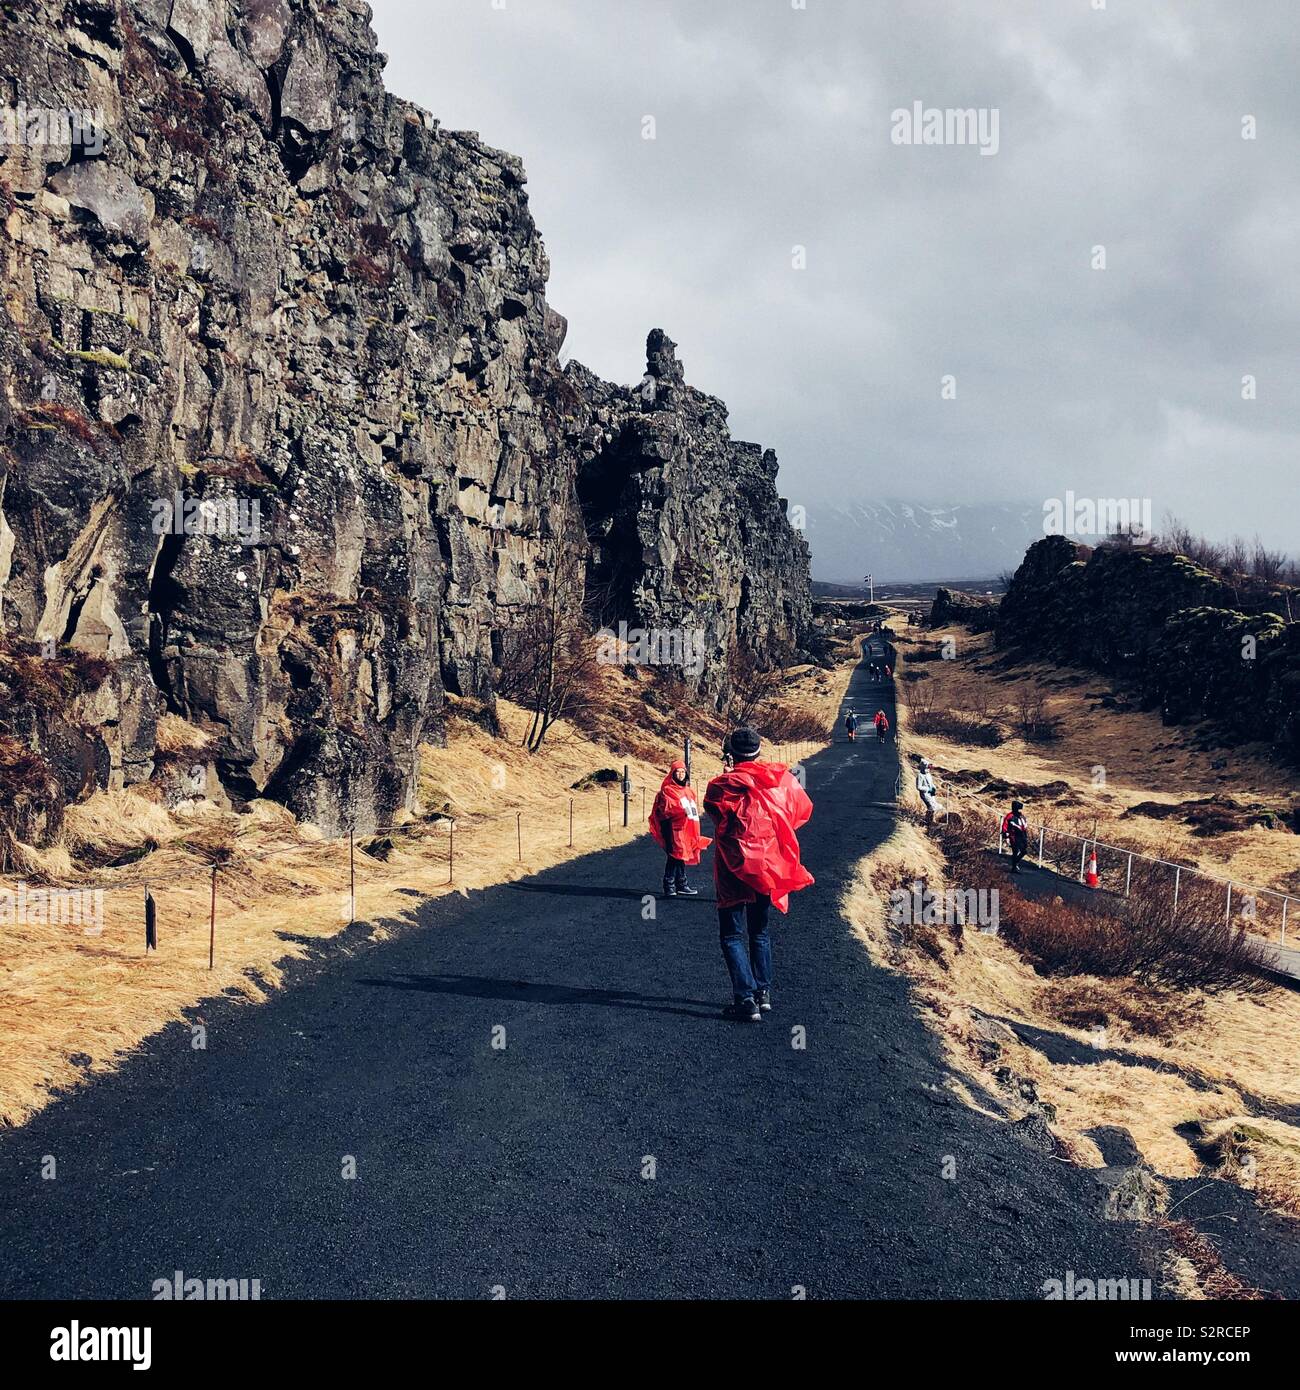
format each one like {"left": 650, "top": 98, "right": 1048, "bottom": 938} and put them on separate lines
{"left": 0, "top": 647, "right": 851, "bottom": 1125}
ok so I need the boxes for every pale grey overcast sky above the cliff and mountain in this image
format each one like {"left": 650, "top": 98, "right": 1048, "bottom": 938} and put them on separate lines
{"left": 373, "top": 0, "right": 1300, "bottom": 550}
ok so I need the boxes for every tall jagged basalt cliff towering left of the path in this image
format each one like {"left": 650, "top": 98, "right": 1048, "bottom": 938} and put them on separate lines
{"left": 0, "top": 0, "right": 809, "bottom": 830}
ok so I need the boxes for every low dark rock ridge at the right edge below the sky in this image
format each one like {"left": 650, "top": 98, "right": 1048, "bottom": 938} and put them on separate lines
{"left": 997, "top": 537, "right": 1300, "bottom": 760}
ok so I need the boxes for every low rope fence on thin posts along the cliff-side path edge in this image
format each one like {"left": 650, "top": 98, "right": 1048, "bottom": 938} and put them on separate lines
{"left": 0, "top": 741, "right": 820, "bottom": 970}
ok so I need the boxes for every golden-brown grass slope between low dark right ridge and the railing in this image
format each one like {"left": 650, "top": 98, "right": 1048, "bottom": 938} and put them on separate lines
{"left": 898, "top": 628, "right": 1300, "bottom": 901}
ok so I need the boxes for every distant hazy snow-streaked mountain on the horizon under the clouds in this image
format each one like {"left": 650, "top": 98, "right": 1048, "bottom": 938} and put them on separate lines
{"left": 806, "top": 499, "right": 1043, "bottom": 584}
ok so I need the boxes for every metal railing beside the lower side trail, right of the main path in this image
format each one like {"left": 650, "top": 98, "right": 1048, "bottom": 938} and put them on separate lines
{"left": 900, "top": 776, "right": 1300, "bottom": 947}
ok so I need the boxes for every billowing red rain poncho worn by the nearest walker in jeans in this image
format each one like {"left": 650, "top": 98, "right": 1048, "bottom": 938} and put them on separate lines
{"left": 704, "top": 763, "right": 813, "bottom": 912}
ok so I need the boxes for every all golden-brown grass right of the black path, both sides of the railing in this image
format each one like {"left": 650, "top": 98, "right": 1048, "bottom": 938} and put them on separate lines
{"left": 844, "top": 608, "right": 1300, "bottom": 1278}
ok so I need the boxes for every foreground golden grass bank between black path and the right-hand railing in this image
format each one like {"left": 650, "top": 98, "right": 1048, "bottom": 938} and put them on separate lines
{"left": 843, "top": 819, "right": 1300, "bottom": 1215}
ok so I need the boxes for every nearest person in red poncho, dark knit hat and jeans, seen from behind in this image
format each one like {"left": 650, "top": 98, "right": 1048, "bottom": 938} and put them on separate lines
{"left": 704, "top": 728, "right": 812, "bottom": 1023}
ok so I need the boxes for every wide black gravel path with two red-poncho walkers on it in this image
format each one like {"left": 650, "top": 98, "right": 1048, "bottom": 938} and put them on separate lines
{"left": 0, "top": 644, "right": 1155, "bottom": 1298}
